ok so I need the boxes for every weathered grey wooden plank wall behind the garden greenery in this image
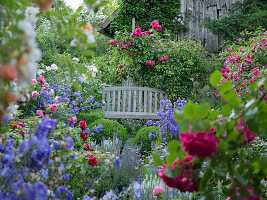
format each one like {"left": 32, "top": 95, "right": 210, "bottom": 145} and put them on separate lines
{"left": 178, "top": 0, "right": 243, "bottom": 52}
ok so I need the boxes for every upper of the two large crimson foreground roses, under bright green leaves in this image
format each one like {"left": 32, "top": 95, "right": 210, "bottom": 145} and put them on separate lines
{"left": 180, "top": 129, "right": 219, "bottom": 158}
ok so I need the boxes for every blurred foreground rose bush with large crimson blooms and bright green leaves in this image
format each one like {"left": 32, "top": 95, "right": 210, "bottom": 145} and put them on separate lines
{"left": 154, "top": 30, "right": 267, "bottom": 199}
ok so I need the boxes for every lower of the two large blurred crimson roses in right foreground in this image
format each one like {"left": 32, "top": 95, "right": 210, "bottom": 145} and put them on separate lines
{"left": 159, "top": 156, "right": 198, "bottom": 192}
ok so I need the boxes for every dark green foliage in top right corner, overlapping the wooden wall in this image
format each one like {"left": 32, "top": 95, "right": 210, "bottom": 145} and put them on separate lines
{"left": 204, "top": 0, "right": 267, "bottom": 40}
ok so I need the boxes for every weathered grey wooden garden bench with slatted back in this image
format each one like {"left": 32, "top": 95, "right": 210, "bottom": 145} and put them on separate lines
{"left": 102, "top": 86, "right": 168, "bottom": 119}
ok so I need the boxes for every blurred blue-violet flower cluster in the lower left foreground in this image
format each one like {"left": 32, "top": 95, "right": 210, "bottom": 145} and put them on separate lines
{"left": 0, "top": 119, "right": 74, "bottom": 200}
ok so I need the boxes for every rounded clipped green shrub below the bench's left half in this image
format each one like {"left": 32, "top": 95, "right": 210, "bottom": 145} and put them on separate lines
{"left": 89, "top": 119, "right": 127, "bottom": 144}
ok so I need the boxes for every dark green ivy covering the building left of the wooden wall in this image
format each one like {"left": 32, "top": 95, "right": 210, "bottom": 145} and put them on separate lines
{"left": 110, "top": 0, "right": 186, "bottom": 34}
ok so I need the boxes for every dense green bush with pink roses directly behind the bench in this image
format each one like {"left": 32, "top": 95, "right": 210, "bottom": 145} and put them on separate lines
{"left": 110, "top": 21, "right": 212, "bottom": 101}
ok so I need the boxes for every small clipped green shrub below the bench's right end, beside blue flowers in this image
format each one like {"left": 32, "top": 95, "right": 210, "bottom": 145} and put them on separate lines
{"left": 135, "top": 126, "right": 160, "bottom": 154}
